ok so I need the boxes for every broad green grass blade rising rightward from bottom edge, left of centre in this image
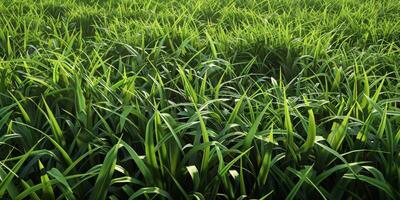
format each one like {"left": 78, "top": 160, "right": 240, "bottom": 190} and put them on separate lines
{"left": 89, "top": 141, "right": 120, "bottom": 200}
